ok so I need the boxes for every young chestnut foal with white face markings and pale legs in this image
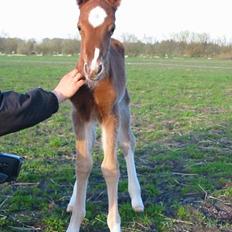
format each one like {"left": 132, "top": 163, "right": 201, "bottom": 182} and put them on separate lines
{"left": 67, "top": 0, "right": 144, "bottom": 232}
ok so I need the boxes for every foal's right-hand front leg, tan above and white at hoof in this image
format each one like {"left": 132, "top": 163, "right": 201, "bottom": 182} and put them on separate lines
{"left": 101, "top": 115, "right": 121, "bottom": 232}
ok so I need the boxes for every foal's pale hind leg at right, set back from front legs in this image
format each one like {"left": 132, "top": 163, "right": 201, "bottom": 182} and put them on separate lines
{"left": 119, "top": 102, "right": 144, "bottom": 212}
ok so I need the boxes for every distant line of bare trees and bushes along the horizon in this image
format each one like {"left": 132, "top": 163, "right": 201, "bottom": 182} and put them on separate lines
{"left": 0, "top": 32, "right": 232, "bottom": 59}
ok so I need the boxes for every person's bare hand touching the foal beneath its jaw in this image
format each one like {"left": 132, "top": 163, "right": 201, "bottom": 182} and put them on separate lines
{"left": 52, "top": 69, "right": 85, "bottom": 103}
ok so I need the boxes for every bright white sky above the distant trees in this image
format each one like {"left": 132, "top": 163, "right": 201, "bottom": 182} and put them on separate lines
{"left": 0, "top": 0, "right": 232, "bottom": 41}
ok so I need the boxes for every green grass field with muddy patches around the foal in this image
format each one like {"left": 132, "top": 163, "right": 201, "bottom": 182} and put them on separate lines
{"left": 0, "top": 56, "right": 232, "bottom": 232}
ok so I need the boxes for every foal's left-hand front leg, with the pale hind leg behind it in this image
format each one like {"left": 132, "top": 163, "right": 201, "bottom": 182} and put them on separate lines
{"left": 67, "top": 114, "right": 95, "bottom": 232}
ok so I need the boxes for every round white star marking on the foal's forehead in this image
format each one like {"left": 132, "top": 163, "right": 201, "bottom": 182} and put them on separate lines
{"left": 89, "top": 6, "right": 107, "bottom": 28}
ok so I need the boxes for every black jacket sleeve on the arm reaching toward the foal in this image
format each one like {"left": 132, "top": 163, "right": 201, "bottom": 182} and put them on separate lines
{"left": 0, "top": 88, "right": 59, "bottom": 136}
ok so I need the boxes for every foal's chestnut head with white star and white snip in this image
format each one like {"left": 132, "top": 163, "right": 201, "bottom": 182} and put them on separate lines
{"left": 77, "top": 0, "right": 120, "bottom": 85}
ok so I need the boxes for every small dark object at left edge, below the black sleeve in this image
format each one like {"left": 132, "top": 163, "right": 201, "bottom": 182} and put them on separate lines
{"left": 0, "top": 153, "right": 23, "bottom": 184}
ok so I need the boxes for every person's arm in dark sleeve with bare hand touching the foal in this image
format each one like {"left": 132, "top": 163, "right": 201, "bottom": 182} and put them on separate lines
{"left": 0, "top": 69, "right": 84, "bottom": 136}
